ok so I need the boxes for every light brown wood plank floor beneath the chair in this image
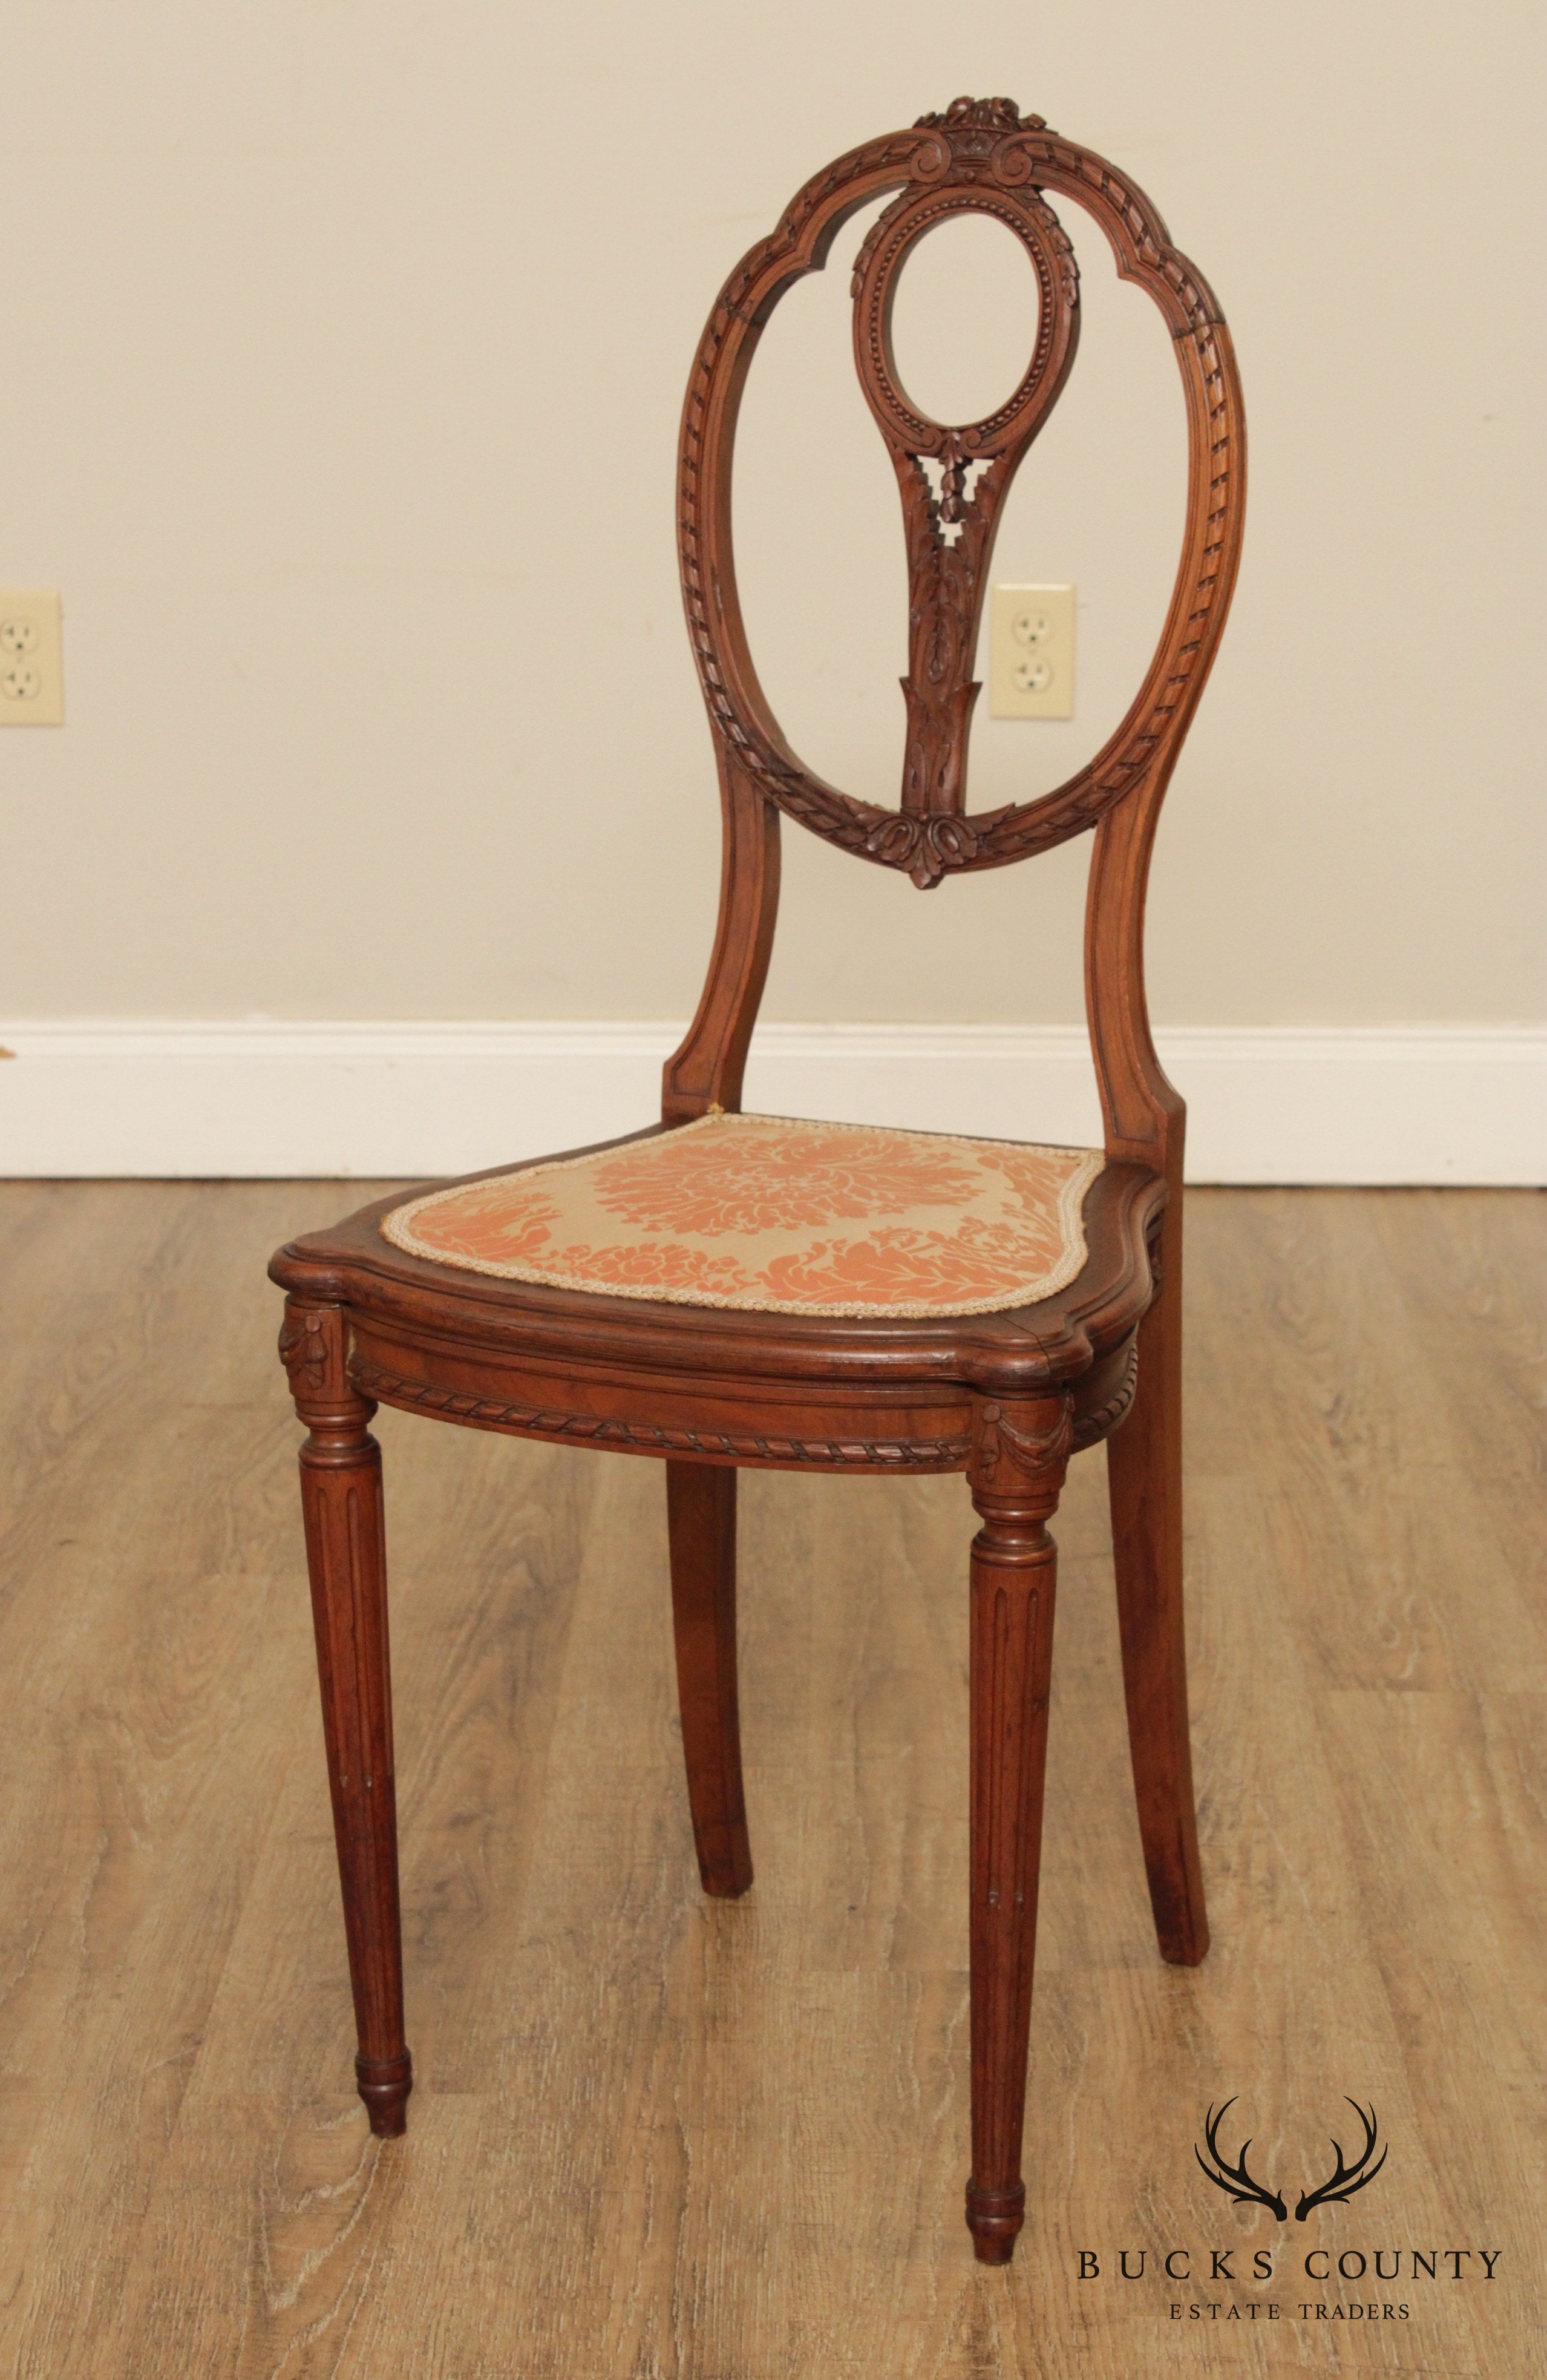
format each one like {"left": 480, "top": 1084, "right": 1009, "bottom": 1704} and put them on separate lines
{"left": 0, "top": 1183, "right": 1547, "bottom": 2380}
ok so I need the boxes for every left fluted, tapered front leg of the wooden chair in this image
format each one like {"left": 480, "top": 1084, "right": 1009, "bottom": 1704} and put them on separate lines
{"left": 278, "top": 1297, "right": 414, "bottom": 2137}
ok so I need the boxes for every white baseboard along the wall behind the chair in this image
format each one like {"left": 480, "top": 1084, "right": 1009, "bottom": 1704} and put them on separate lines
{"left": 0, "top": 1021, "right": 1547, "bottom": 1185}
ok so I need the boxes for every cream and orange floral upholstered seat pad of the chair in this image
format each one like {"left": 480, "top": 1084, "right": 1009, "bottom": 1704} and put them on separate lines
{"left": 381, "top": 1114, "right": 1104, "bottom": 1316}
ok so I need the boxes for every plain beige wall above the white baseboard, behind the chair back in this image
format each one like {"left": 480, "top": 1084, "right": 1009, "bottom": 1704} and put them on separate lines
{"left": 0, "top": 0, "right": 1547, "bottom": 1023}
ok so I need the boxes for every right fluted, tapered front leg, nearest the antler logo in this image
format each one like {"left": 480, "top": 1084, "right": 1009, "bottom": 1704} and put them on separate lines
{"left": 966, "top": 1397, "right": 1073, "bottom": 2263}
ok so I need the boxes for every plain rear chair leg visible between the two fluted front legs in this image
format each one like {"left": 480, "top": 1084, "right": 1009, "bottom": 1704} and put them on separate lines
{"left": 666, "top": 1461, "right": 752, "bottom": 1900}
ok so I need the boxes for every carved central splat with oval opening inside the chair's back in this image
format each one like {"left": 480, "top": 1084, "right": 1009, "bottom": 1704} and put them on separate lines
{"left": 852, "top": 174, "right": 1081, "bottom": 866}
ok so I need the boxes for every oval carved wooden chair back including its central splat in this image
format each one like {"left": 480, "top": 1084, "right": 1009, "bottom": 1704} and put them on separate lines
{"left": 678, "top": 100, "right": 1244, "bottom": 888}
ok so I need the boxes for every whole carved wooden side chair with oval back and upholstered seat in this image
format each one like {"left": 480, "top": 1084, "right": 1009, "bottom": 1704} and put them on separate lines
{"left": 271, "top": 100, "right": 1244, "bottom": 2263}
